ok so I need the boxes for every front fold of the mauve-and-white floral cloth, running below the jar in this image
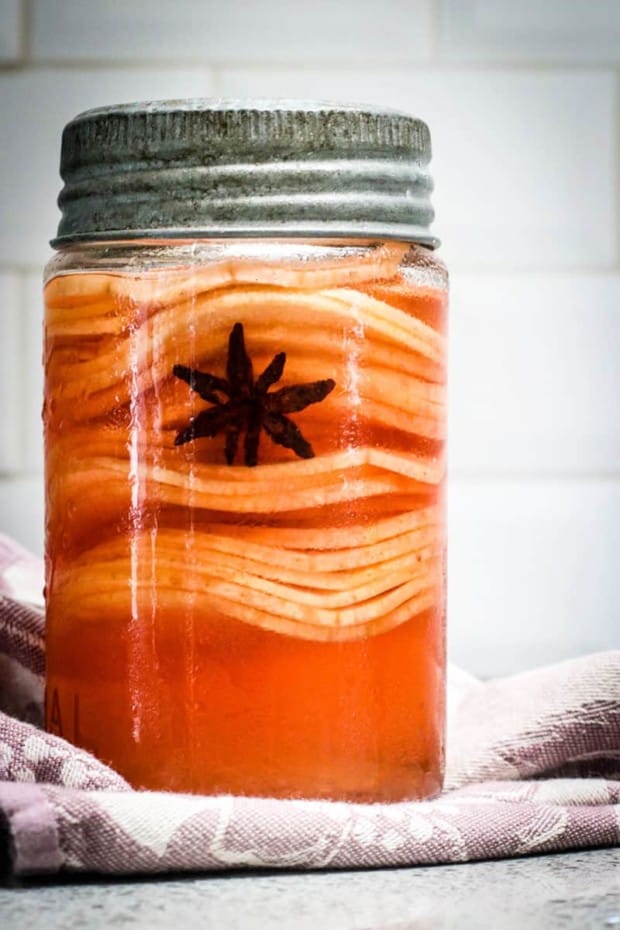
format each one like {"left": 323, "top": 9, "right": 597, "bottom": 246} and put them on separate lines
{"left": 0, "top": 779, "right": 620, "bottom": 874}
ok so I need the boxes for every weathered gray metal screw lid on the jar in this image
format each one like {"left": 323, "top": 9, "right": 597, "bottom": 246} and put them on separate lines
{"left": 52, "top": 99, "right": 438, "bottom": 248}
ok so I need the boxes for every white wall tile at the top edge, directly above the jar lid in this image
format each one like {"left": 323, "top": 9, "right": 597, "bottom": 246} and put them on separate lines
{"left": 32, "top": 0, "right": 435, "bottom": 64}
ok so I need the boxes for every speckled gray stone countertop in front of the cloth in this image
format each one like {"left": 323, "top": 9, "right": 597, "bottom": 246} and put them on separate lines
{"left": 0, "top": 849, "right": 620, "bottom": 930}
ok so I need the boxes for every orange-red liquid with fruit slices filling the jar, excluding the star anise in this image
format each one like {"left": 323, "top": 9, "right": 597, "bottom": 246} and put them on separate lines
{"left": 45, "top": 245, "right": 445, "bottom": 801}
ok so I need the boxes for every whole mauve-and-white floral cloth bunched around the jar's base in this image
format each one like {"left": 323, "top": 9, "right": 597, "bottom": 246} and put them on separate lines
{"left": 0, "top": 537, "right": 620, "bottom": 876}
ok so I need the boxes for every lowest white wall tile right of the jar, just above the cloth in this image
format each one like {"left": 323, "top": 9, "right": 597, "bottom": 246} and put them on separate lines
{"left": 448, "top": 477, "right": 620, "bottom": 675}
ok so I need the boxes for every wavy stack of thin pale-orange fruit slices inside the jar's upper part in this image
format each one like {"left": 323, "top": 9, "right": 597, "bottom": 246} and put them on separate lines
{"left": 46, "top": 244, "right": 446, "bottom": 642}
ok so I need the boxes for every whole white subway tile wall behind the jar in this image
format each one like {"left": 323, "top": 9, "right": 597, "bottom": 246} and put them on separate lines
{"left": 0, "top": 0, "right": 620, "bottom": 675}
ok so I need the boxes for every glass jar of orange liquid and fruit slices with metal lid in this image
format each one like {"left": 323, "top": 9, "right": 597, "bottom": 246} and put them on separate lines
{"left": 44, "top": 101, "right": 447, "bottom": 801}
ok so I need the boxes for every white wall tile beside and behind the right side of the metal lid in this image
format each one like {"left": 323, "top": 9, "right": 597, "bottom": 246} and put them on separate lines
{"left": 216, "top": 67, "right": 620, "bottom": 271}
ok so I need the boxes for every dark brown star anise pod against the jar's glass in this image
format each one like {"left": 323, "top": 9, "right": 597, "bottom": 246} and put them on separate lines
{"left": 172, "top": 323, "right": 336, "bottom": 466}
